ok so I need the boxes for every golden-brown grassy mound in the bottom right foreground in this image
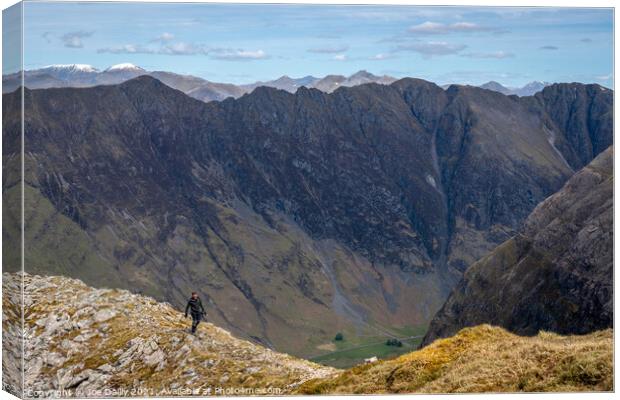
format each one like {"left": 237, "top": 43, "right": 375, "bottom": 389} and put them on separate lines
{"left": 298, "top": 325, "right": 613, "bottom": 394}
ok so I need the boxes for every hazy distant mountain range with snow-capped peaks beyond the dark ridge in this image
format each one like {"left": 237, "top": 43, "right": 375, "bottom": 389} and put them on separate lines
{"left": 2, "top": 63, "right": 549, "bottom": 102}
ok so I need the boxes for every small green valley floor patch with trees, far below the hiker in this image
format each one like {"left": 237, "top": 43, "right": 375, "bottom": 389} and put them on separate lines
{"left": 310, "top": 326, "right": 427, "bottom": 368}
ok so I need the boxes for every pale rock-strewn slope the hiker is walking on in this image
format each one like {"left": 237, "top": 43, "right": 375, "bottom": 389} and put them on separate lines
{"left": 2, "top": 273, "right": 337, "bottom": 397}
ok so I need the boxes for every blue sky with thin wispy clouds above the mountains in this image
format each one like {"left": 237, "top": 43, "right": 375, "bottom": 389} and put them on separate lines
{"left": 4, "top": 2, "right": 613, "bottom": 87}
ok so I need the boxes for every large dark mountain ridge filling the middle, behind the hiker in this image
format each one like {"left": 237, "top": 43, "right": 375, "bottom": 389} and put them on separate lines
{"left": 3, "top": 76, "right": 611, "bottom": 355}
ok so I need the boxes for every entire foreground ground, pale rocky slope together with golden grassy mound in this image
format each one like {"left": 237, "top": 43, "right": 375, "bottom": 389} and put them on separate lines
{"left": 2, "top": 273, "right": 613, "bottom": 398}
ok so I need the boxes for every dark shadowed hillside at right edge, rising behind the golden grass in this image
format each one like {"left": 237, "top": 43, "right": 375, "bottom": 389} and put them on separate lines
{"left": 423, "top": 147, "right": 613, "bottom": 344}
